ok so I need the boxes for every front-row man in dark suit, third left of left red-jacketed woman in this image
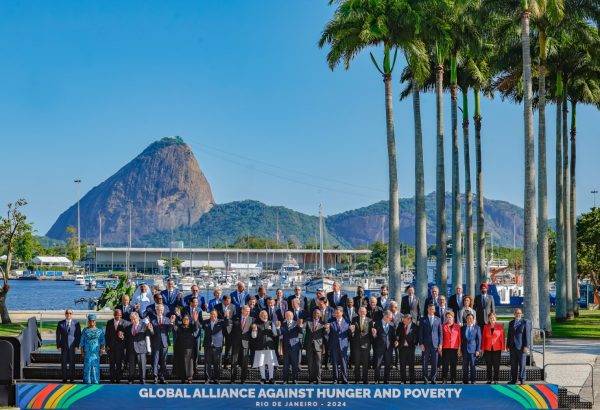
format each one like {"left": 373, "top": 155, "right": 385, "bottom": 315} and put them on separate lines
{"left": 371, "top": 310, "right": 397, "bottom": 384}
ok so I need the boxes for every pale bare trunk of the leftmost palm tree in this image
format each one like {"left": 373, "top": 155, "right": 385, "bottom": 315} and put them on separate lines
{"left": 383, "top": 74, "right": 402, "bottom": 300}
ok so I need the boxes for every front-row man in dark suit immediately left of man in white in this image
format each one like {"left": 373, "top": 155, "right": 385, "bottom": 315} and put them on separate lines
{"left": 225, "top": 306, "right": 254, "bottom": 384}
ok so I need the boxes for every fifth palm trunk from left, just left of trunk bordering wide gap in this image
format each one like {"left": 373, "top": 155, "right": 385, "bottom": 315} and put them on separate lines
{"left": 462, "top": 89, "right": 475, "bottom": 295}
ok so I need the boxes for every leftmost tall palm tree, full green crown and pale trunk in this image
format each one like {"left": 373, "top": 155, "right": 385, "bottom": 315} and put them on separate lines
{"left": 319, "top": 0, "right": 425, "bottom": 300}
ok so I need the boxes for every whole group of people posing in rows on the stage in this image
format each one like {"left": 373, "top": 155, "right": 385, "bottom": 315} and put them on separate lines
{"left": 56, "top": 280, "right": 532, "bottom": 384}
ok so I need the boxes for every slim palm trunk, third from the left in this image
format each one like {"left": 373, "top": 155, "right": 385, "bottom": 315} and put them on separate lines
{"left": 435, "top": 64, "right": 448, "bottom": 295}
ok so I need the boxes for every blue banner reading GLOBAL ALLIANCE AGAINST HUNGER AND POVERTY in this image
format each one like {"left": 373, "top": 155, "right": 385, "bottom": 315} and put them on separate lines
{"left": 17, "top": 383, "right": 558, "bottom": 410}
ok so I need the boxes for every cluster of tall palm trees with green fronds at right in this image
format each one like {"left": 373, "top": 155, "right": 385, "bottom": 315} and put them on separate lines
{"left": 319, "top": 0, "right": 600, "bottom": 332}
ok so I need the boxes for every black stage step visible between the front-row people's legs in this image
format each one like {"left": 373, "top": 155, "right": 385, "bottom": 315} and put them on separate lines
{"left": 23, "top": 363, "right": 543, "bottom": 383}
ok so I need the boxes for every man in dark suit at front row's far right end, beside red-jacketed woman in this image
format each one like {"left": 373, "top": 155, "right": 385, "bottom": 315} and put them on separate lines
{"left": 506, "top": 308, "right": 532, "bottom": 384}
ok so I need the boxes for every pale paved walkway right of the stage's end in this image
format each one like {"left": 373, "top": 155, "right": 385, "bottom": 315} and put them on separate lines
{"left": 534, "top": 339, "right": 600, "bottom": 409}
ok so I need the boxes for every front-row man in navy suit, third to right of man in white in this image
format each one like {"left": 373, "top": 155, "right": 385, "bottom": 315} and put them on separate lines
{"left": 325, "top": 306, "right": 350, "bottom": 384}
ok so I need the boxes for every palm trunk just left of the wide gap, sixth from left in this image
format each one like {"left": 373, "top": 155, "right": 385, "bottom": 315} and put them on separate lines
{"left": 473, "top": 88, "right": 487, "bottom": 283}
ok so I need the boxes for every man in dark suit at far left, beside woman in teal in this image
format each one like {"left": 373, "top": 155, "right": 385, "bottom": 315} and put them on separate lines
{"left": 56, "top": 309, "right": 81, "bottom": 383}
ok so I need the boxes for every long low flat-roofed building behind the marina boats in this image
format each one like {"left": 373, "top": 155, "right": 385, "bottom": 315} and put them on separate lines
{"left": 93, "top": 247, "right": 371, "bottom": 273}
